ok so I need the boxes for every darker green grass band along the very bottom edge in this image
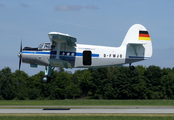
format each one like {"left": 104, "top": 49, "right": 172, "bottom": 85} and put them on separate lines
{"left": 0, "top": 116, "right": 174, "bottom": 120}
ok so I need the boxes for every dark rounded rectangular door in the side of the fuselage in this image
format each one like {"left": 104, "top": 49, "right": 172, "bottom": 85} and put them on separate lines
{"left": 83, "top": 51, "right": 92, "bottom": 65}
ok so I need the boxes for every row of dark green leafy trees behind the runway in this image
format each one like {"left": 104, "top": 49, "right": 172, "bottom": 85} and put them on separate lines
{"left": 0, "top": 66, "right": 174, "bottom": 100}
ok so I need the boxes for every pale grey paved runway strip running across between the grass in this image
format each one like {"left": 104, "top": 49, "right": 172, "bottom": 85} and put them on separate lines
{"left": 0, "top": 109, "right": 174, "bottom": 114}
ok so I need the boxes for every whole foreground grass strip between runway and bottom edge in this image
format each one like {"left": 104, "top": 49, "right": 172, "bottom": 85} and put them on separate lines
{"left": 0, "top": 114, "right": 174, "bottom": 120}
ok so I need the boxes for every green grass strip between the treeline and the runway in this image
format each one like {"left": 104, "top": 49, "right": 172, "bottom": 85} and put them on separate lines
{"left": 0, "top": 100, "right": 174, "bottom": 106}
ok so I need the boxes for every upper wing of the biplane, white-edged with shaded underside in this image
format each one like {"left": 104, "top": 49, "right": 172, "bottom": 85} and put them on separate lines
{"left": 48, "top": 32, "right": 77, "bottom": 46}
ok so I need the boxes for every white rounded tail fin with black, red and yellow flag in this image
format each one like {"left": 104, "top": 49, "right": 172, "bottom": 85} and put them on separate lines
{"left": 121, "top": 24, "right": 152, "bottom": 59}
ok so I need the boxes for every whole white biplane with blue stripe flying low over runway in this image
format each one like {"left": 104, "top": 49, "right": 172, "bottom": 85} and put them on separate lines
{"left": 18, "top": 24, "right": 152, "bottom": 83}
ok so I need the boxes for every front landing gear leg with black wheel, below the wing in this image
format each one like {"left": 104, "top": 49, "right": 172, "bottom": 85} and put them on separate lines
{"left": 41, "top": 66, "right": 54, "bottom": 83}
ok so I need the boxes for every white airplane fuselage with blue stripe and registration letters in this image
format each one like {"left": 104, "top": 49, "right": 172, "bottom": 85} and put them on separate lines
{"left": 22, "top": 44, "right": 146, "bottom": 68}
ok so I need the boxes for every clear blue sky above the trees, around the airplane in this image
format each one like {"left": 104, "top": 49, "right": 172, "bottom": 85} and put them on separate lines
{"left": 0, "top": 0, "right": 174, "bottom": 75}
